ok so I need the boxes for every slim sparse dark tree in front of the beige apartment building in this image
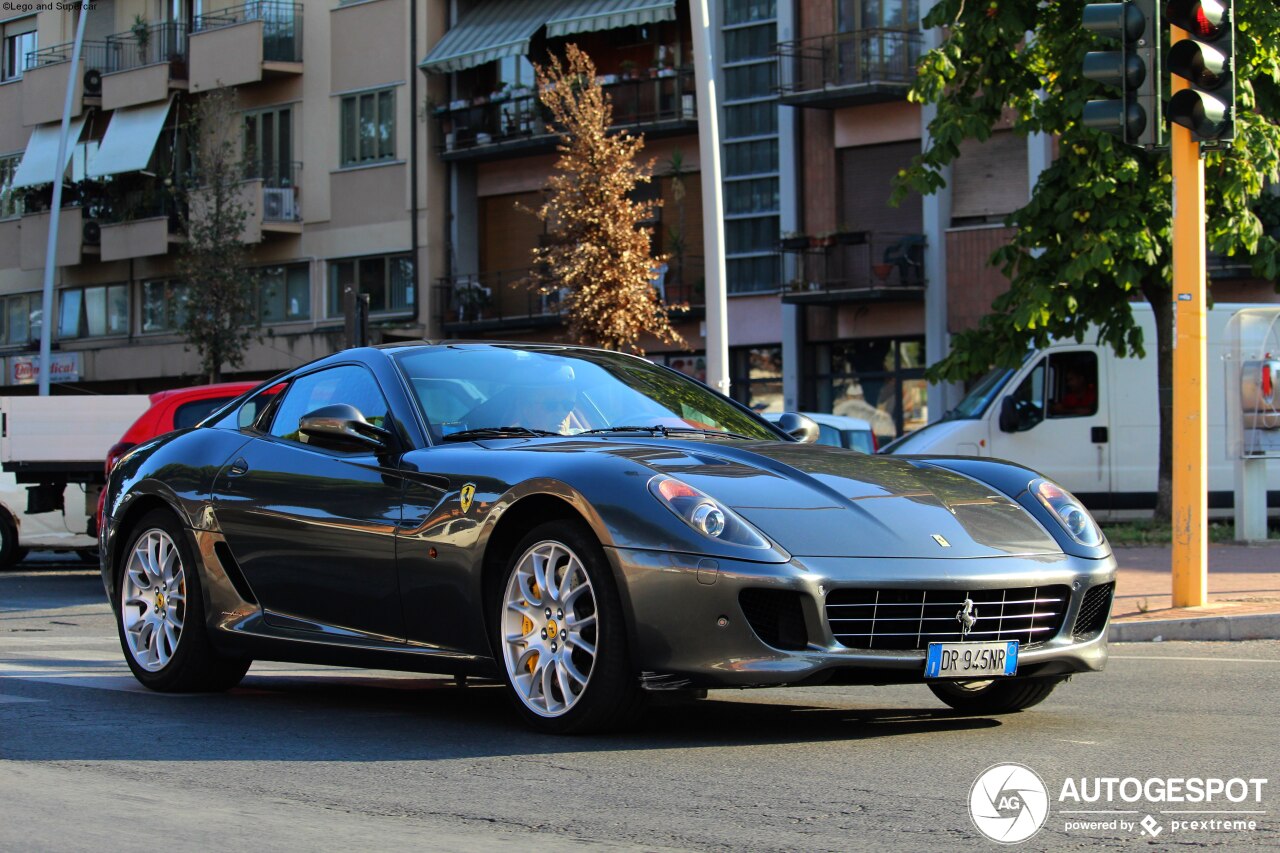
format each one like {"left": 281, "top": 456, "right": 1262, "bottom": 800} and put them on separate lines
{"left": 177, "top": 88, "right": 257, "bottom": 383}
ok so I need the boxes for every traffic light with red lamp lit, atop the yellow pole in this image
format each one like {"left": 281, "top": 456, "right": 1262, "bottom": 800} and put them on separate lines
{"left": 1169, "top": 0, "right": 1235, "bottom": 143}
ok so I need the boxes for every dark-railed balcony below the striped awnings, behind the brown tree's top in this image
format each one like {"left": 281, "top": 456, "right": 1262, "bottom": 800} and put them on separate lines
{"left": 435, "top": 68, "right": 698, "bottom": 160}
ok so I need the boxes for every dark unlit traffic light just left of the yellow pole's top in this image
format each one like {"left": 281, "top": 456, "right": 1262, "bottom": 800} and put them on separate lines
{"left": 1084, "top": 0, "right": 1162, "bottom": 149}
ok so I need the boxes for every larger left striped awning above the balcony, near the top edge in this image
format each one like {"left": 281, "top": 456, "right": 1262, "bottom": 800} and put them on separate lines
{"left": 419, "top": 0, "right": 552, "bottom": 74}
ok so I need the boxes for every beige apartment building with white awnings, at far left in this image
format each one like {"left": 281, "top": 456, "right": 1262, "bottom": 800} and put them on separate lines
{"left": 0, "top": 0, "right": 443, "bottom": 392}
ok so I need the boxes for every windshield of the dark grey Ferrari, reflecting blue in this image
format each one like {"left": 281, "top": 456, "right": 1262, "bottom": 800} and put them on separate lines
{"left": 394, "top": 345, "right": 780, "bottom": 442}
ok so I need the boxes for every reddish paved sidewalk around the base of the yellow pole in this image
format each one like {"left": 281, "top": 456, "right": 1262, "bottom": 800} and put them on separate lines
{"left": 1108, "top": 542, "right": 1280, "bottom": 643}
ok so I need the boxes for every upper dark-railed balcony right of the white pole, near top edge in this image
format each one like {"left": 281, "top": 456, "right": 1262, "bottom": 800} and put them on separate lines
{"left": 777, "top": 29, "right": 922, "bottom": 109}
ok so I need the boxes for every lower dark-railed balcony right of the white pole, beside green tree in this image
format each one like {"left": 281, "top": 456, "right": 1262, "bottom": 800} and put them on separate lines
{"left": 780, "top": 231, "right": 925, "bottom": 305}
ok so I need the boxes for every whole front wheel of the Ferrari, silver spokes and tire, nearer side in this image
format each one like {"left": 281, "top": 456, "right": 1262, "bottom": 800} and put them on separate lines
{"left": 493, "top": 520, "right": 644, "bottom": 734}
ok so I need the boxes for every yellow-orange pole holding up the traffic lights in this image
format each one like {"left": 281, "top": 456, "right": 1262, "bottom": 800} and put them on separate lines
{"left": 1172, "top": 21, "right": 1208, "bottom": 607}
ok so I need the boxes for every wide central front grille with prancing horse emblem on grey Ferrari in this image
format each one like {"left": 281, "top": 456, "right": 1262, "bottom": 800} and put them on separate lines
{"left": 827, "top": 585, "right": 1071, "bottom": 651}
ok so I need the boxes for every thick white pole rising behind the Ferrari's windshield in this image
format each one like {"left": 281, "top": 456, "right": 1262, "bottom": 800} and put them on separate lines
{"left": 689, "top": 0, "right": 728, "bottom": 394}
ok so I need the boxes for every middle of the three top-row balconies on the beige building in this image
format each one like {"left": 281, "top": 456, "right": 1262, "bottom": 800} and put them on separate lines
{"left": 102, "top": 20, "right": 187, "bottom": 110}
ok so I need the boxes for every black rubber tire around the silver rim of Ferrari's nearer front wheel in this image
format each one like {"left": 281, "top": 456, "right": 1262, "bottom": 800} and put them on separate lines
{"left": 489, "top": 520, "right": 645, "bottom": 734}
